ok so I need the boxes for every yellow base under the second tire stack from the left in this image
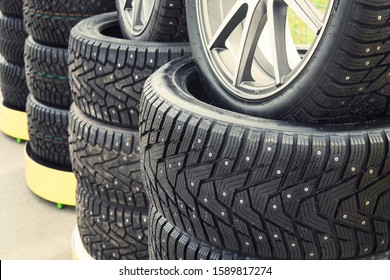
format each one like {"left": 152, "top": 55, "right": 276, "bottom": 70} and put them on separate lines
{"left": 25, "top": 144, "right": 77, "bottom": 208}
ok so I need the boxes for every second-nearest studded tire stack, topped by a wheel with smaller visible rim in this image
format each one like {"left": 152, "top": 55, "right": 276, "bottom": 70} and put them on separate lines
{"left": 69, "top": 0, "right": 190, "bottom": 260}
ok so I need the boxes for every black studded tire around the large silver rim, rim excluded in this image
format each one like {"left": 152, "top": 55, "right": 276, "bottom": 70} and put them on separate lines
{"left": 186, "top": 0, "right": 390, "bottom": 124}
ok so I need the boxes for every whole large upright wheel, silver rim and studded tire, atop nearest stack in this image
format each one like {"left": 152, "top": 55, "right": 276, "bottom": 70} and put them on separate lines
{"left": 186, "top": 0, "right": 390, "bottom": 124}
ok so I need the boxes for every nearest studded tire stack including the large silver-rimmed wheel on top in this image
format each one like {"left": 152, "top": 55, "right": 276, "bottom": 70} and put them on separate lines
{"left": 139, "top": 0, "right": 390, "bottom": 260}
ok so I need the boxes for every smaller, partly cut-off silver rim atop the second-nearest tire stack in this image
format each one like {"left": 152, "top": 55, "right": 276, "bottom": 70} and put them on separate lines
{"left": 119, "top": 0, "right": 156, "bottom": 36}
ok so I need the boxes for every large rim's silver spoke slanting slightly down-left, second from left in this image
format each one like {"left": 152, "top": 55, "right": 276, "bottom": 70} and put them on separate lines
{"left": 234, "top": 1, "right": 267, "bottom": 86}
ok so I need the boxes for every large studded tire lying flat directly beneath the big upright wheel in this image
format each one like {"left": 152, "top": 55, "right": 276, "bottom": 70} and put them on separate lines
{"left": 140, "top": 58, "right": 390, "bottom": 259}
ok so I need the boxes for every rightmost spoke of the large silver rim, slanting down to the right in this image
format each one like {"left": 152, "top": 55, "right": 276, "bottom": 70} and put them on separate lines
{"left": 284, "top": 0, "right": 324, "bottom": 34}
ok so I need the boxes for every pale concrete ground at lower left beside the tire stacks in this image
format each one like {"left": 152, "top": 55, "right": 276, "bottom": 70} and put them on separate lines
{"left": 0, "top": 97, "right": 76, "bottom": 260}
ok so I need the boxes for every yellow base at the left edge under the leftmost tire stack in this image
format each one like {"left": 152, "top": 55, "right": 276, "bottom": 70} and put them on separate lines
{"left": 0, "top": 104, "right": 29, "bottom": 140}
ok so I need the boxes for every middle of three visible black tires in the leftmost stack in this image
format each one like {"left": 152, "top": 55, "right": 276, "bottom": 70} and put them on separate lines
{"left": 0, "top": 14, "right": 27, "bottom": 66}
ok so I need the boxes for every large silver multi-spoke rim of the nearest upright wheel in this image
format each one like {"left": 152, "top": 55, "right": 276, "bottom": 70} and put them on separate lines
{"left": 196, "top": 0, "right": 334, "bottom": 100}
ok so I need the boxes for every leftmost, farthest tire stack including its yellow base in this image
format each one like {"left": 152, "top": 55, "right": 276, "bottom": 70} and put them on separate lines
{"left": 0, "top": 0, "right": 28, "bottom": 141}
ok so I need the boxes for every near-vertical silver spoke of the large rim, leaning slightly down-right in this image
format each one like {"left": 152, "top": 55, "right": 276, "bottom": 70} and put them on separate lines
{"left": 267, "top": 0, "right": 291, "bottom": 86}
